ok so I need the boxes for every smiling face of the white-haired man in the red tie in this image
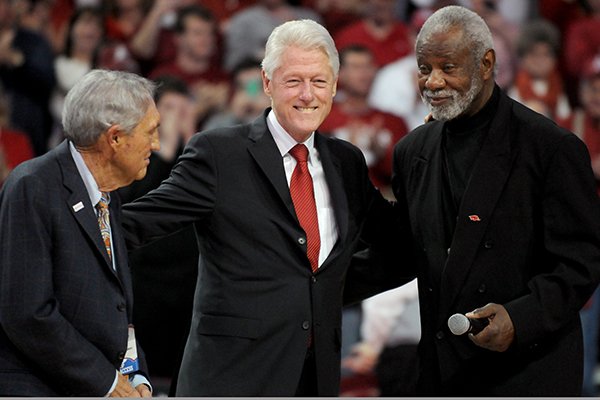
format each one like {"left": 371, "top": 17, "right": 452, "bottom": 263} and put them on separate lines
{"left": 262, "top": 47, "right": 337, "bottom": 143}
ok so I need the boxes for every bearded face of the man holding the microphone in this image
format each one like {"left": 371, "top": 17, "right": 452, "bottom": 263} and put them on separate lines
{"left": 417, "top": 29, "right": 494, "bottom": 121}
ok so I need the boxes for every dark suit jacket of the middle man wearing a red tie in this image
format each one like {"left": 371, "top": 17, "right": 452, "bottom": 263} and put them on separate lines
{"left": 123, "top": 112, "right": 398, "bottom": 396}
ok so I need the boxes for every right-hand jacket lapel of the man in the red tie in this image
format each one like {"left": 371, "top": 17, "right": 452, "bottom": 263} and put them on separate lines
{"left": 315, "top": 133, "right": 348, "bottom": 271}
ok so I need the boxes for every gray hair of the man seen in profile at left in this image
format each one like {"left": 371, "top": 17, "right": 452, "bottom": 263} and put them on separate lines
{"left": 62, "top": 69, "right": 156, "bottom": 146}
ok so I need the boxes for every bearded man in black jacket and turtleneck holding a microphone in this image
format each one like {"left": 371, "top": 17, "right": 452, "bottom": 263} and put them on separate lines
{"left": 393, "top": 6, "right": 600, "bottom": 397}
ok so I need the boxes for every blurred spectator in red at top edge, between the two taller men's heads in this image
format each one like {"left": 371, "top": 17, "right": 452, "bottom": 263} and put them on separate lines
{"left": 334, "top": 0, "right": 413, "bottom": 67}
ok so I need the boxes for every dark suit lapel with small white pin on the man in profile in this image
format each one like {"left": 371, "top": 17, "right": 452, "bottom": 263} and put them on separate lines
{"left": 57, "top": 141, "right": 114, "bottom": 274}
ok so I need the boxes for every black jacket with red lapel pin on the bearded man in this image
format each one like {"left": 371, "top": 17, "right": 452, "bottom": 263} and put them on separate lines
{"left": 393, "top": 88, "right": 600, "bottom": 396}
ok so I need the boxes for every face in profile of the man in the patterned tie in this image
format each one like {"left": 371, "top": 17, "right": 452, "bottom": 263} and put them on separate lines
{"left": 115, "top": 103, "right": 160, "bottom": 186}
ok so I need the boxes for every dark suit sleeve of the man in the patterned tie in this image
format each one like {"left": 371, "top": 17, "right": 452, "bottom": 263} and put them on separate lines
{"left": 0, "top": 177, "right": 115, "bottom": 396}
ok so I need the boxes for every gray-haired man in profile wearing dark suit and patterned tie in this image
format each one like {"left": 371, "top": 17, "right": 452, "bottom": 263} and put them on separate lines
{"left": 0, "top": 70, "right": 160, "bottom": 397}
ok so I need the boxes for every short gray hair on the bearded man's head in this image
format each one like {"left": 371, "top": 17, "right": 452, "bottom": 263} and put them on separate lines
{"left": 416, "top": 6, "right": 494, "bottom": 62}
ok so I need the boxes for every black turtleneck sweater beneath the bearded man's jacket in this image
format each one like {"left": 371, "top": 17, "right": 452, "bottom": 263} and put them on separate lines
{"left": 442, "top": 86, "right": 500, "bottom": 247}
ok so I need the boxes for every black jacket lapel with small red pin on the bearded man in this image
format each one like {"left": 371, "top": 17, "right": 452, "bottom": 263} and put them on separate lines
{"left": 441, "top": 95, "right": 514, "bottom": 307}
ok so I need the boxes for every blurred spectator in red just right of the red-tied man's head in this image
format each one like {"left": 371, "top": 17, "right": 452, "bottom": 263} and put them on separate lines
{"left": 319, "top": 45, "right": 408, "bottom": 194}
